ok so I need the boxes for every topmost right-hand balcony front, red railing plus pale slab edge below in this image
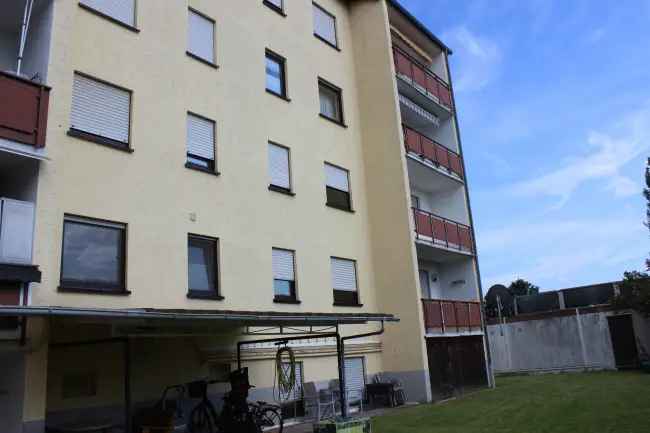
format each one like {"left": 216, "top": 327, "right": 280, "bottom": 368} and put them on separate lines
{"left": 393, "top": 46, "right": 453, "bottom": 119}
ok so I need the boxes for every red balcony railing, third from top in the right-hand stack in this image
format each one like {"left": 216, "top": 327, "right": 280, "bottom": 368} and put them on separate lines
{"left": 413, "top": 208, "right": 474, "bottom": 253}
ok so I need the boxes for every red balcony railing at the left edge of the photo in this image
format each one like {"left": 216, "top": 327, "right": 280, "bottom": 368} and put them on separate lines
{"left": 0, "top": 71, "right": 50, "bottom": 147}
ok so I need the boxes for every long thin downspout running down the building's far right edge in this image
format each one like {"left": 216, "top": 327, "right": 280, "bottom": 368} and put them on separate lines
{"left": 445, "top": 49, "right": 494, "bottom": 388}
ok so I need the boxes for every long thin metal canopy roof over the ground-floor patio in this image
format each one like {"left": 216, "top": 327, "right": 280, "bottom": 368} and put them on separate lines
{"left": 0, "top": 306, "right": 399, "bottom": 326}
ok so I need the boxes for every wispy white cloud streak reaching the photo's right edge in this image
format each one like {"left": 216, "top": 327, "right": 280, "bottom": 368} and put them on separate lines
{"left": 510, "top": 104, "right": 650, "bottom": 208}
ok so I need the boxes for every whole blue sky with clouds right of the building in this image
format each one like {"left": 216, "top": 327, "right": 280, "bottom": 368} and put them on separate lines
{"left": 401, "top": 0, "right": 650, "bottom": 291}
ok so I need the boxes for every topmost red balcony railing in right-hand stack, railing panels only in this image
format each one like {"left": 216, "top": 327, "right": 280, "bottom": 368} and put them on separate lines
{"left": 393, "top": 46, "right": 452, "bottom": 110}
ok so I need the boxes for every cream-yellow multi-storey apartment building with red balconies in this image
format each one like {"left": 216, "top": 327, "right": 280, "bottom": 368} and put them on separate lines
{"left": 0, "top": 0, "right": 490, "bottom": 432}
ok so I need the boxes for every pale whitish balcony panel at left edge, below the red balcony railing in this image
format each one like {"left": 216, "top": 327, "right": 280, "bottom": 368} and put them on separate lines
{"left": 0, "top": 199, "right": 34, "bottom": 264}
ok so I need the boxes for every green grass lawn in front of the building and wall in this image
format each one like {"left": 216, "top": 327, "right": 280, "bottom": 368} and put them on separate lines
{"left": 373, "top": 372, "right": 650, "bottom": 433}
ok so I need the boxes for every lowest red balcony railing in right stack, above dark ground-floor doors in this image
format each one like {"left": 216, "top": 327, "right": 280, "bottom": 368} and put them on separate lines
{"left": 422, "top": 299, "right": 481, "bottom": 333}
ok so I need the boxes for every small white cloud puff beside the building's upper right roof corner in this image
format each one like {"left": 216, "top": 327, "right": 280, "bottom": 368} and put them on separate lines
{"left": 443, "top": 26, "right": 502, "bottom": 92}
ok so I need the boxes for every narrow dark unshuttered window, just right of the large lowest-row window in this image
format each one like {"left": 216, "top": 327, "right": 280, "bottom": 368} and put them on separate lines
{"left": 187, "top": 235, "right": 221, "bottom": 299}
